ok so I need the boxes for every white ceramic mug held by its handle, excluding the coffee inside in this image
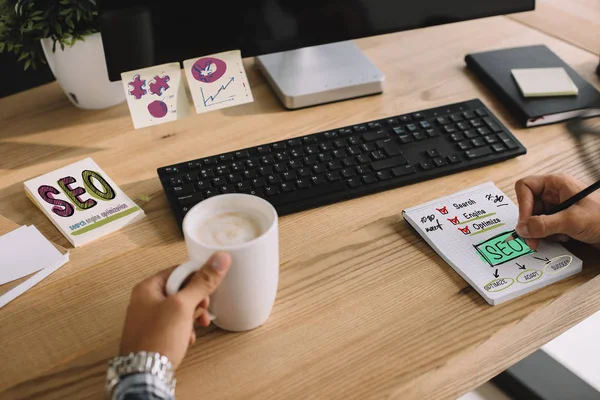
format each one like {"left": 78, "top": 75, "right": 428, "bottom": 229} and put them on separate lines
{"left": 167, "top": 193, "right": 279, "bottom": 331}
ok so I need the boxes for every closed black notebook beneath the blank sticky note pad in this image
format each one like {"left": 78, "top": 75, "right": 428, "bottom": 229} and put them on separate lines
{"left": 465, "top": 45, "right": 600, "bottom": 127}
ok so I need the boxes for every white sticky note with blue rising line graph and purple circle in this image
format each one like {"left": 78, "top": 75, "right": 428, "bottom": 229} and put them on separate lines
{"left": 183, "top": 50, "right": 254, "bottom": 113}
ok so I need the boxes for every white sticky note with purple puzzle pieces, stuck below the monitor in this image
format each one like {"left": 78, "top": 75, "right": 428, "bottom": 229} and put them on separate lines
{"left": 121, "top": 62, "right": 189, "bottom": 129}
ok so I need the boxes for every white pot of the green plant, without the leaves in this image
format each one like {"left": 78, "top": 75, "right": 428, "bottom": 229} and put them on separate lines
{"left": 42, "top": 33, "right": 125, "bottom": 109}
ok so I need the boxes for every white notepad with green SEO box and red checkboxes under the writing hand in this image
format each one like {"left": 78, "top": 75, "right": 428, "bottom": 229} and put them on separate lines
{"left": 402, "top": 182, "right": 582, "bottom": 305}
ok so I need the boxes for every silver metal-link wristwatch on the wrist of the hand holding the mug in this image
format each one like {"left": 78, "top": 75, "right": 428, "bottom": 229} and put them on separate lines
{"left": 105, "top": 351, "right": 176, "bottom": 398}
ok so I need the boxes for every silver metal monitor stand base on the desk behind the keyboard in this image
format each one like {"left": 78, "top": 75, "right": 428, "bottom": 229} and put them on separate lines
{"left": 256, "top": 41, "right": 385, "bottom": 109}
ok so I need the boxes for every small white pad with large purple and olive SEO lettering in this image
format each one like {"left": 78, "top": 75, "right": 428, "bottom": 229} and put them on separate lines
{"left": 25, "top": 158, "right": 145, "bottom": 247}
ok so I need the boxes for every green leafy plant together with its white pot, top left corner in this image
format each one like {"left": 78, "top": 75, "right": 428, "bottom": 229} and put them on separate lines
{"left": 0, "top": 0, "right": 125, "bottom": 109}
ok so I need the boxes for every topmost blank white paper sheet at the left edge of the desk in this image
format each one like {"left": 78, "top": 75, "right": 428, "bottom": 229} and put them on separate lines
{"left": 0, "top": 226, "right": 64, "bottom": 285}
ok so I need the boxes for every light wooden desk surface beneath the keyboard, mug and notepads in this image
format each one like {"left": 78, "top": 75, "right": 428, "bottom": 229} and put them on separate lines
{"left": 0, "top": 9, "right": 600, "bottom": 399}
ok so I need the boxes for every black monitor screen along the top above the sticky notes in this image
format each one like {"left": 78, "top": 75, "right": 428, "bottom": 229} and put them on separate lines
{"left": 98, "top": 0, "right": 534, "bottom": 80}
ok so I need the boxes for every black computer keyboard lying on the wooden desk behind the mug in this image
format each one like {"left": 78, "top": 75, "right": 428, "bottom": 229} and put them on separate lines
{"left": 158, "top": 99, "right": 527, "bottom": 226}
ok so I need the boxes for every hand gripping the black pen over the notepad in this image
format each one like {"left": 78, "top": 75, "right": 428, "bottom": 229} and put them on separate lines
{"left": 508, "top": 175, "right": 600, "bottom": 250}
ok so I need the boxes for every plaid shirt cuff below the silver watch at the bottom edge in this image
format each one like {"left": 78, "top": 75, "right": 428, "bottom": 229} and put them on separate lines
{"left": 113, "top": 374, "right": 175, "bottom": 400}
